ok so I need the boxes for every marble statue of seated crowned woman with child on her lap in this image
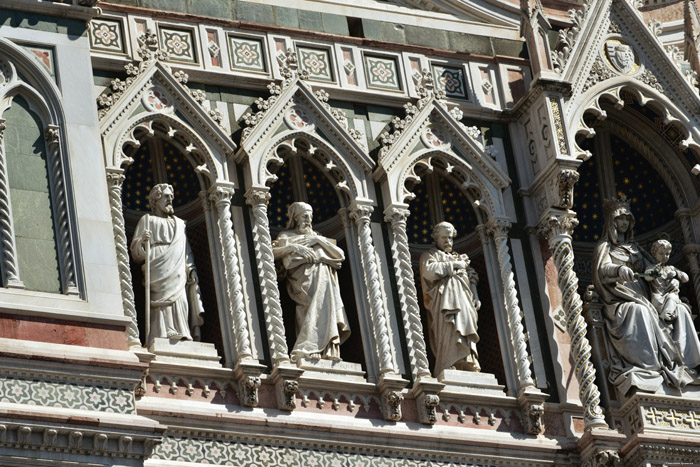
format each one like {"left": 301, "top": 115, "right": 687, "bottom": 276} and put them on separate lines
{"left": 593, "top": 196, "right": 700, "bottom": 394}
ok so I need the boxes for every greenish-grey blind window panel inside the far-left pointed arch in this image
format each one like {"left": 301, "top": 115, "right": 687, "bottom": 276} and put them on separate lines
{"left": 2, "top": 96, "right": 61, "bottom": 293}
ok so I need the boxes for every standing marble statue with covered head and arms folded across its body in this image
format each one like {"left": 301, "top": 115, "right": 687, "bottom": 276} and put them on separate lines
{"left": 272, "top": 202, "right": 350, "bottom": 362}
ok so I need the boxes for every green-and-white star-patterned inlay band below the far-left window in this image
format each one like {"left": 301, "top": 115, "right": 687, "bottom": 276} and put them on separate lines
{"left": 0, "top": 376, "right": 136, "bottom": 413}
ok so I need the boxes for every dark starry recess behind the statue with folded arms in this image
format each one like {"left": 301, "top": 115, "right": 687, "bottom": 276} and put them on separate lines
{"left": 268, "top": 144, "right": 367, "bottom": 371}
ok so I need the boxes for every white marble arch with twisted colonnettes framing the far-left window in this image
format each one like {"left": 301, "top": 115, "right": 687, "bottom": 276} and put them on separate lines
{"left": 0, "top": 38, "right": 82, "bottom": 295}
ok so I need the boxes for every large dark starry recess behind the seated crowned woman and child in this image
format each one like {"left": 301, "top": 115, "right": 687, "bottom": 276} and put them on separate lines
{"left": 573, "top": 86, "right": 700, "bottom": 410}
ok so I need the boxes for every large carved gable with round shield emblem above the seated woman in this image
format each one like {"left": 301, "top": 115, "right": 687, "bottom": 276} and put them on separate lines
{"left": 561, "top": 0, "right": 700, "bottom": 156}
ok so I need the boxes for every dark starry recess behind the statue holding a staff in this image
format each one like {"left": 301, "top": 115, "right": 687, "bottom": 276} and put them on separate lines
{"left": 122, "top": 135, "right": 225, "bottom": 355}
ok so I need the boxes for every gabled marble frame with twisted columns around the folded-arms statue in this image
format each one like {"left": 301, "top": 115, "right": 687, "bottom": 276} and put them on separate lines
{"left": 236, "top": 77, "right": 398, "bottom": 379}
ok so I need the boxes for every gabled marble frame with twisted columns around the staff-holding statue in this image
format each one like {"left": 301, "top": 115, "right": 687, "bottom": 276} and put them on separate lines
{"left": 100, "top": 56, "right": 242, "bottom": 354}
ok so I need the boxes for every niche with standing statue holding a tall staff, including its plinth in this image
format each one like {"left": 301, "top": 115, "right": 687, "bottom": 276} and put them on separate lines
{"left": 122, "top": 136, "right": 226, "bottom": 367}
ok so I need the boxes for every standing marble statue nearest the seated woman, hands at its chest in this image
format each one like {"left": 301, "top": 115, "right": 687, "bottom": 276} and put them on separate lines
{"left": 420, "top": 222, "right": 481, "bottom": 374}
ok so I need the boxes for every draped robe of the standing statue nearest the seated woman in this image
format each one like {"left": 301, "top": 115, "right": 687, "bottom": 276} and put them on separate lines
{"left": 420, "top": 248, "right": 479, "bottom": 374}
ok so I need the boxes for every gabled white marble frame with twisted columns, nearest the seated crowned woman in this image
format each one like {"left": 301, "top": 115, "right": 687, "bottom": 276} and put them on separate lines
{"left": 374, "top": 77, "right": 546, "bottom": 433}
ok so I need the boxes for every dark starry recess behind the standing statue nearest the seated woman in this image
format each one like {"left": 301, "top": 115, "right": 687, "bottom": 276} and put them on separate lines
{"left": 406, "top": 170, "right": 506, "bottom": 385}
